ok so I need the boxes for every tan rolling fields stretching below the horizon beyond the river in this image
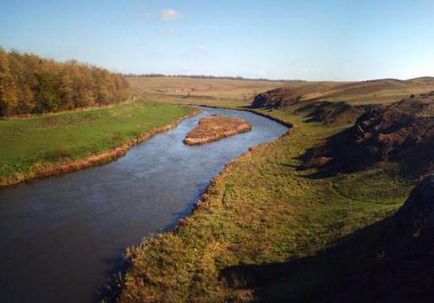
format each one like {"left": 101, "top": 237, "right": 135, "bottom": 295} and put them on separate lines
{"left": 128, "top": 77, "right": 434, "bottom": 107}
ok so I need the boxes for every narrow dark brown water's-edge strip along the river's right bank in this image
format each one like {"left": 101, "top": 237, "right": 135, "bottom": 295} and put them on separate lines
{"left": 113, "top": 105, "right": 295, "bottom": 303}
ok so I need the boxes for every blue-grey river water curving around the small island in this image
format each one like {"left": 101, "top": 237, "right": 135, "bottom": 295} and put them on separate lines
{"left": 0, "top": 108, "right": 287, "bottom": 303}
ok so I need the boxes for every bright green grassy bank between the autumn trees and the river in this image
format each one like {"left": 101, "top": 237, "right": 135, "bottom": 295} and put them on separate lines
{"left": 0, "top": 101, "right": 191, "bottom": 184}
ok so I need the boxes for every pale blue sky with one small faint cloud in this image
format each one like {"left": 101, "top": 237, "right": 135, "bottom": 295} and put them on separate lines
{"left": 0, "top": 0, "right": 434, "bottom": 81}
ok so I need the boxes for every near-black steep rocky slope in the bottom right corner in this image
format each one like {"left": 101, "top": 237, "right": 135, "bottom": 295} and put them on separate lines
{"left": 325, "top": 175, "right": 434, "bottom": 302}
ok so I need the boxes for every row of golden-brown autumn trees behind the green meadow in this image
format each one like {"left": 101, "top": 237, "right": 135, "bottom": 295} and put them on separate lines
{"left": 0, "top": 48, "right": 128, "bottom": 116}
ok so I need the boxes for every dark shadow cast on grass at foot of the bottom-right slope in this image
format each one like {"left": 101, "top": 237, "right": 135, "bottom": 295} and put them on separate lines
{"left": 221, "top": 217, "right": 386, "bottom": 302}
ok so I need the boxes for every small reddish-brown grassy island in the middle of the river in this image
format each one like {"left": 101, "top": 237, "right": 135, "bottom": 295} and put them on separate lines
{"left": 184, "top": 115, "right": 252, "bottom": 145}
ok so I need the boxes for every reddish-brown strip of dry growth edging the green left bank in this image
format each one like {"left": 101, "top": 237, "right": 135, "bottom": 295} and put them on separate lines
{"left": 0, "top": 108, "right": 201, "bottom": 189}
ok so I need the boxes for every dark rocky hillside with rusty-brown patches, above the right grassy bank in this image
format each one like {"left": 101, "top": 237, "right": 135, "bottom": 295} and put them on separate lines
{"left": 306, "top": 92, "right": 434, "bottom": 178}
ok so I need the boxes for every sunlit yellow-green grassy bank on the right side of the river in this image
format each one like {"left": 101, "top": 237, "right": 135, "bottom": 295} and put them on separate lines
{"left": 120, "top": 110, "right": 410, "bottom": 302}
